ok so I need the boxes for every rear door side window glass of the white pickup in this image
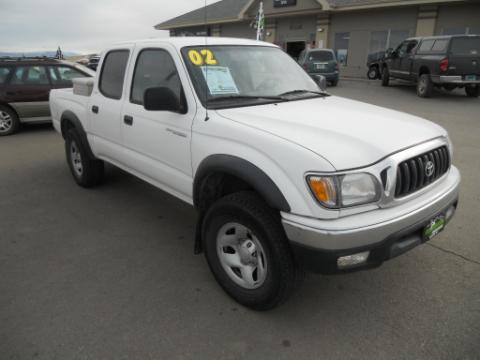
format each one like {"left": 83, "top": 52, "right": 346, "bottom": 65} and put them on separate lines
{"left": 99, "top": 50, "right": 130, "bottom": 100}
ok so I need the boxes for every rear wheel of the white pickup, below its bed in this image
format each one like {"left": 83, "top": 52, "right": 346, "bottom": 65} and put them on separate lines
{"left": 65, "top": 129, "right": 104, "bottom": 188}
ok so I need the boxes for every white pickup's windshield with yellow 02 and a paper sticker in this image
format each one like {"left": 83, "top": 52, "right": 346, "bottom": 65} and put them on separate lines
{"left": 182, "top": 45, "right": 321, "bottom": 108}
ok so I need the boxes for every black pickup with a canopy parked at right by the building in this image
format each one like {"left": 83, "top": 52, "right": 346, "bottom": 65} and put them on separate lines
{"left": 381, "top": 35, "right": 480, "bottom": 97}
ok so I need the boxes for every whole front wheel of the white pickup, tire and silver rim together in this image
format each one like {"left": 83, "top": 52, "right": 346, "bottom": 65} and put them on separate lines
{"left": 203, "top": 191, "right": 302, "bottom": 310}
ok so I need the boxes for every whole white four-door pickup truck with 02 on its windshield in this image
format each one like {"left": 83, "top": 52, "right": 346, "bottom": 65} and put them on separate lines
{"left": 50, "top": 37, "right": 460, "bottom": 310}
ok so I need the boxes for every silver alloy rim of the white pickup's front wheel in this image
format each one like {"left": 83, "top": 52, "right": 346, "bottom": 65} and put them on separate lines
{"left": 217, "top": 222, "right": 267, "bottom": 289}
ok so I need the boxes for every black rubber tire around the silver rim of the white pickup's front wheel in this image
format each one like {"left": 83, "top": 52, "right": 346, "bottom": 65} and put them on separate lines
{"left": 202, "top": 191, "right": 303, "bottom": 311}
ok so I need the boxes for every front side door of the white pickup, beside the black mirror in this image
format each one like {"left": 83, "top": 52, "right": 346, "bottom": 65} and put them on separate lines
{"left": 121, "top": 45, "right": 196, "bottom": 198}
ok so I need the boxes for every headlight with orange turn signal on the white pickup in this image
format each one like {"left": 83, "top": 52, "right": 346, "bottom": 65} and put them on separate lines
{"left": 307, "top": 173, "right": 380, "bottom": 209}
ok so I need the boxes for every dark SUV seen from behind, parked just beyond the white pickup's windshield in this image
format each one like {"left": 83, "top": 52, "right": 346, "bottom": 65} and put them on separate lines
{"left": 298, "top": 49, "right": 339, "bottom": 86}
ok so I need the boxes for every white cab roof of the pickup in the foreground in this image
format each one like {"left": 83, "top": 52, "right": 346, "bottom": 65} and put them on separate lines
{"left": 109, "top": 36, "right": 278, "bottom": 49}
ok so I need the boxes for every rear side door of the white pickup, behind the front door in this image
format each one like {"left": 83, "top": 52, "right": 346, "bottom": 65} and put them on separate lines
{"left": 87, "top": 46, "right": 133, "bottom": 162}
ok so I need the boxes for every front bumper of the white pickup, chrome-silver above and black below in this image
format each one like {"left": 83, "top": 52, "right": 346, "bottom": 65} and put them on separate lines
{"left": 282, "top": 166, "right": 460, "bottom": 273}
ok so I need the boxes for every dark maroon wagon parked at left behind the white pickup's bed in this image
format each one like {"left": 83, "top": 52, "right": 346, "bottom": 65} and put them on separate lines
{"left": 0, "top": 58, "right": 94, "bottom": 136}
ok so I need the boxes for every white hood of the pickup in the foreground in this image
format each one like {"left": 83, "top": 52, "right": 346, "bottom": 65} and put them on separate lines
{"left": 217, "top": 96, "right": 447, "bottom": 170}
